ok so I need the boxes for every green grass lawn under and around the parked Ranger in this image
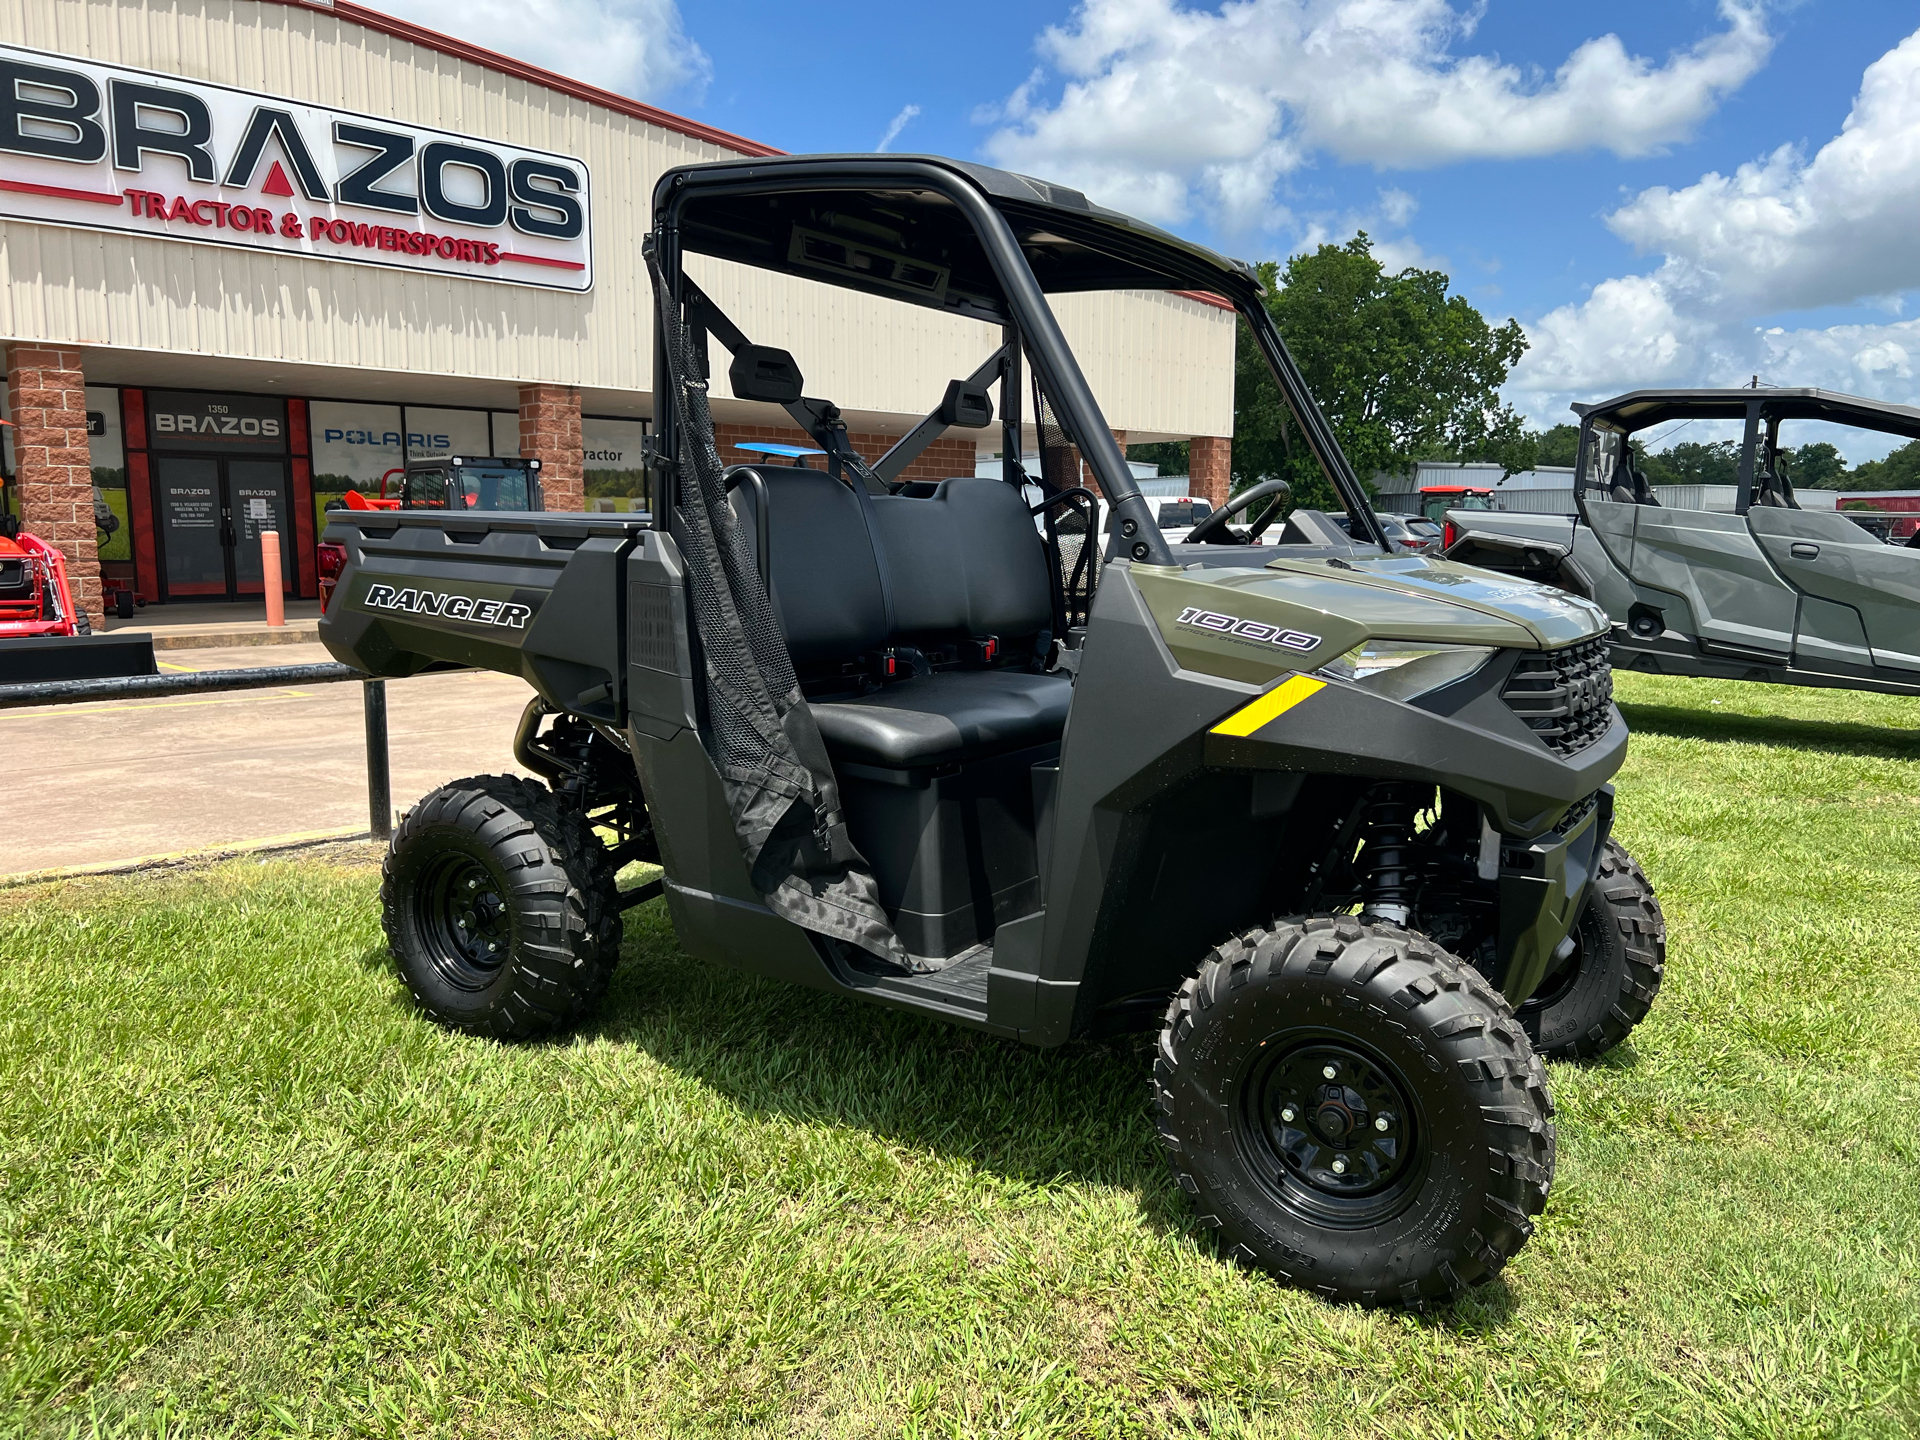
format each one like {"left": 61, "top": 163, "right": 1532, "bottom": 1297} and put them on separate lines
{"left": 0, "top": 676, "right": 1920, "bottom": 1436}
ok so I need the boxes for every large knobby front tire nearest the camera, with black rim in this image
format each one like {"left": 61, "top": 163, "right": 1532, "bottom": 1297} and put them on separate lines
{"left": 1154, "top": 916, "right": 1553, "bottom": 1308}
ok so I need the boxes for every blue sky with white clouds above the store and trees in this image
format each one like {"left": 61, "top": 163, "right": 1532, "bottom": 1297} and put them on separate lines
{"left": 386, "top": 0, "right": 1920, "bottom": 459}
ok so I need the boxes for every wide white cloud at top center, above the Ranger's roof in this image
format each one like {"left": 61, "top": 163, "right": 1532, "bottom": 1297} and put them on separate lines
{"left": 985, "top": 0, "right": 1772, "bottom": 228}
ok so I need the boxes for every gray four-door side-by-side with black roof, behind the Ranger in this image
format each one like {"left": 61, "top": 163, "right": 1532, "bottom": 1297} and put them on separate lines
{"left": 1446, "top": 390, "right": 1920, "bottom": 695}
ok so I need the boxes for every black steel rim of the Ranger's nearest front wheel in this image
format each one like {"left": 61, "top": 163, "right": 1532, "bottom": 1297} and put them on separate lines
{"left": 1235, "top": 1031, "right": 1427, "bottom": 1229}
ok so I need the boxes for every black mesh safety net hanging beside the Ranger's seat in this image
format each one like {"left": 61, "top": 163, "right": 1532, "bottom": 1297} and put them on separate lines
{"left": 647, "top": 248, "right": 912, "bottom": 970}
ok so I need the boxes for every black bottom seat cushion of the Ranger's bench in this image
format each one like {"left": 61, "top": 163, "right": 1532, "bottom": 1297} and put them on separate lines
{"left": 812, "top": 670, "right": 1073, "bottom": 770}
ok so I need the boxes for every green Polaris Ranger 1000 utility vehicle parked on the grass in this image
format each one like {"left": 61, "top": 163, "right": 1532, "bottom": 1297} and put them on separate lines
{"left": 321, "top": 156, "right": 1665, "bottom": 1306}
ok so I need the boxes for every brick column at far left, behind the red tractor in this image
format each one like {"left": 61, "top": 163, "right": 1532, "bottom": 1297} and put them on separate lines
{"left": 6, "top": 346, "right": 106, "bottom": 630}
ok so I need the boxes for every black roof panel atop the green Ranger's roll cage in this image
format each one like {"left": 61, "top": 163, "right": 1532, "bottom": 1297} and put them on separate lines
{"left": 655, "top": 156, "right": 1260, "bottom": 321}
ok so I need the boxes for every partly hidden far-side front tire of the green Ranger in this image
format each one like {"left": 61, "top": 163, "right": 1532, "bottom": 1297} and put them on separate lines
{"left": 1517, "top": 839, "right": 1667, "bottom": 1060}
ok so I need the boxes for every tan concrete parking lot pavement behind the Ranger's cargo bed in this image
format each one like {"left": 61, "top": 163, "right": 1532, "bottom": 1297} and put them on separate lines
{"left": 0, "top": 645, "right": 532, "bottom": 874}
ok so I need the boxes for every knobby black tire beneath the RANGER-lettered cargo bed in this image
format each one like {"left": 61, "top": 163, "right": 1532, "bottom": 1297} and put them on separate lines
{"left": 380, "top": 776, "right": 620, "bottom": 1041}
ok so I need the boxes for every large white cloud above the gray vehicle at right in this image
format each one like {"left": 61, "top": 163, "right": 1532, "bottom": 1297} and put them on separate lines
{"left": 1509, "top": 33, "right": 1920, "bottom": 422}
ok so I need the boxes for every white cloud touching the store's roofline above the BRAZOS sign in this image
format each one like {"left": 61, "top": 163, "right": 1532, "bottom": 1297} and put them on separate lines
{"left": 378, "top": 0, "right": 712, "bottom": 100}
